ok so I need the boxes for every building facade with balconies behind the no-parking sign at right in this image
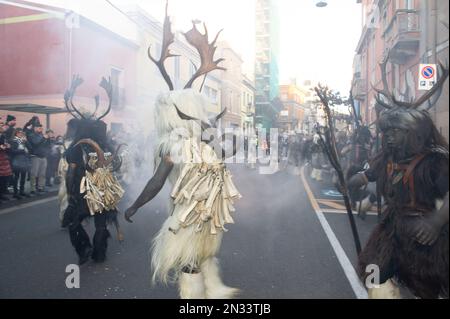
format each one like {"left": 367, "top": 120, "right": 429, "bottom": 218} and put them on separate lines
{"left": 353, "top": 0, "right": 449, "bottom": 140}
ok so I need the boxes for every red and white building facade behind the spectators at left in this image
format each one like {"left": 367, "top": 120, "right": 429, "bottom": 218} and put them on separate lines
{"left": 0, "top": 2, "right": 138, "bottom": 134}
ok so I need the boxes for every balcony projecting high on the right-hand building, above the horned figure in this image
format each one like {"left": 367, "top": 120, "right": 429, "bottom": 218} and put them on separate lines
{"left": 383, "top": 10, "right": 421, "bottom": 64}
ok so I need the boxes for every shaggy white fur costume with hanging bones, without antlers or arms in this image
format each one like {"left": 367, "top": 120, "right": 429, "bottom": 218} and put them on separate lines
{"left": 151, "top": 90, "right": 240, "bottom": 299}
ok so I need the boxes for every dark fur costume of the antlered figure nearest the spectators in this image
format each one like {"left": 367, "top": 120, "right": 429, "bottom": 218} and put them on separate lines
{"left": 63, "top": 119, "right": 117, "bottom": 263}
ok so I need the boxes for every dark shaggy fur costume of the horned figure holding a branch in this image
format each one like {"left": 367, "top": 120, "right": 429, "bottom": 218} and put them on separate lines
{"left": 359, "top": 111, "right": 449, "bottom": 298}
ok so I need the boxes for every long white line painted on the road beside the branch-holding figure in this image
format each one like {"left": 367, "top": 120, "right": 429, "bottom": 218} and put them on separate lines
{"left": 300, "top": 166, "right": 368, "bottom": 299}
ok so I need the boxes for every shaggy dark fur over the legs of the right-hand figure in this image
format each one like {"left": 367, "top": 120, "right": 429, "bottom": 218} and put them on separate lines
{"left": 359, "top": 210, "right": 449, "bottom": 299}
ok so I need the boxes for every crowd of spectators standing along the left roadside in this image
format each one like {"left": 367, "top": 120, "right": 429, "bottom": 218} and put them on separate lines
{"left": 0, "top": 115, "right": 64, "bottom": 205}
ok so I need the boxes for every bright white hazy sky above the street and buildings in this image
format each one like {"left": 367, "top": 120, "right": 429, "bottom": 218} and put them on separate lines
{"left": 23, "top": 0, "right": 362, "bottom": 96}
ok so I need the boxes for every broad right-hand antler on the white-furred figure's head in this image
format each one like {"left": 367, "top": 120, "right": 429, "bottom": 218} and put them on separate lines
{"left": 184, "top": 22, "right": 226, "bottom": 89}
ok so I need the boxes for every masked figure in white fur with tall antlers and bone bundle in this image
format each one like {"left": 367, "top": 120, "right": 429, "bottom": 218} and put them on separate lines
{"left": 125, "top": 1, "right": 240, "bottom": 299}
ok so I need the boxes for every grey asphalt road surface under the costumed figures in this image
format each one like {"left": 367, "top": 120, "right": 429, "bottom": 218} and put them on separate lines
{"left": 0, "top": 166, "right": 376, "bottom": 299}
